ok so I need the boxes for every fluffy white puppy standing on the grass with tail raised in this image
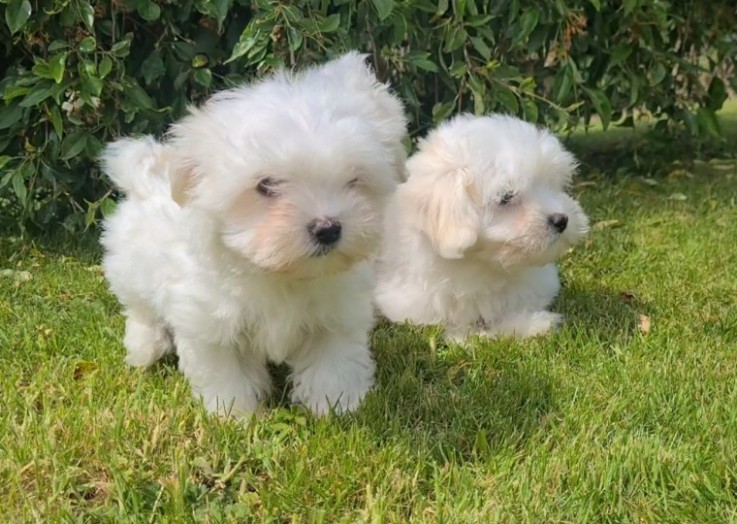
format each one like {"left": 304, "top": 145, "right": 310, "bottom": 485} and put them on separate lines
{"left": 102, "top": 53, "right": 406, "bottom": 414}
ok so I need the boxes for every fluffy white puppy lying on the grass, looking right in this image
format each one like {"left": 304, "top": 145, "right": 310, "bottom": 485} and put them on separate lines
{"left": 376, "top": 115, "right": 588, "bottom": 340}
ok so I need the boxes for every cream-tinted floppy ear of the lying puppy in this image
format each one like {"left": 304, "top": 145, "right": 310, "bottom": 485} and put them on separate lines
{"left": 405, "top": 169, "right": 480, "bottom": 259}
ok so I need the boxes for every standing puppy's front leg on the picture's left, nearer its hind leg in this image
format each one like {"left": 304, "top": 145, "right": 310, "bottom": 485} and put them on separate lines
{"left": 177, "top": 338, "right": 271, "bottom": 417}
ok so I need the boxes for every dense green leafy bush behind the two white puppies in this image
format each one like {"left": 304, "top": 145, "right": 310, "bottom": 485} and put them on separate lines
{"left": 0, "top": 0, "right": 737, "bottom": 229}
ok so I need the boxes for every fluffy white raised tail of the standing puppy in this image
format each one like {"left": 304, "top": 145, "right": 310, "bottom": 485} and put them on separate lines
{"left": 100, "top": 136, "right": 171, "bottom": 200}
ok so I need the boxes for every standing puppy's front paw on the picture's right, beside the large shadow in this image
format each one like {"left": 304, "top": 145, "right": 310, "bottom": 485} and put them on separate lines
{"left": 292, "top": 340, "right": 375, "bottom": 416}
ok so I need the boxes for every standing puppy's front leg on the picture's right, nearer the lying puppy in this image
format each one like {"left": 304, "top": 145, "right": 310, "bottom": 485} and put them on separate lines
{"left": 289, "top": 332, "right": 375, "bottom": 415}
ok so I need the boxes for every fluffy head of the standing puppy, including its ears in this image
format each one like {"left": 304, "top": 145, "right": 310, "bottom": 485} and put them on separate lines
{"left": 170, "top": 54, "right": 406, "bottom": 278}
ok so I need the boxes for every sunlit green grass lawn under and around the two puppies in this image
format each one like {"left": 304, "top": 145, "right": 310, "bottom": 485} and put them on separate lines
{"left": 0, "top": 106, "right": 737, "bottom": 523}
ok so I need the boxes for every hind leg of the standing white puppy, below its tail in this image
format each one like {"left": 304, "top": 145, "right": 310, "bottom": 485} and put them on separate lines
{"left": 123, "top": 309, "right": 174, "bottom": 367}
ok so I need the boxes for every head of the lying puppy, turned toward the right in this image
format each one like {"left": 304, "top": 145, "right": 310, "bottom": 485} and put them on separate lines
{"left": 400, "top": 115, "right": 588, "bottom": 268}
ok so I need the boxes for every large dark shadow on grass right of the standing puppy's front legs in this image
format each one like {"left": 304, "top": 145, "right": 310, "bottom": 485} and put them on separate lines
{"left": 358, "top": 323, "right": 556, "bottom": 462}
